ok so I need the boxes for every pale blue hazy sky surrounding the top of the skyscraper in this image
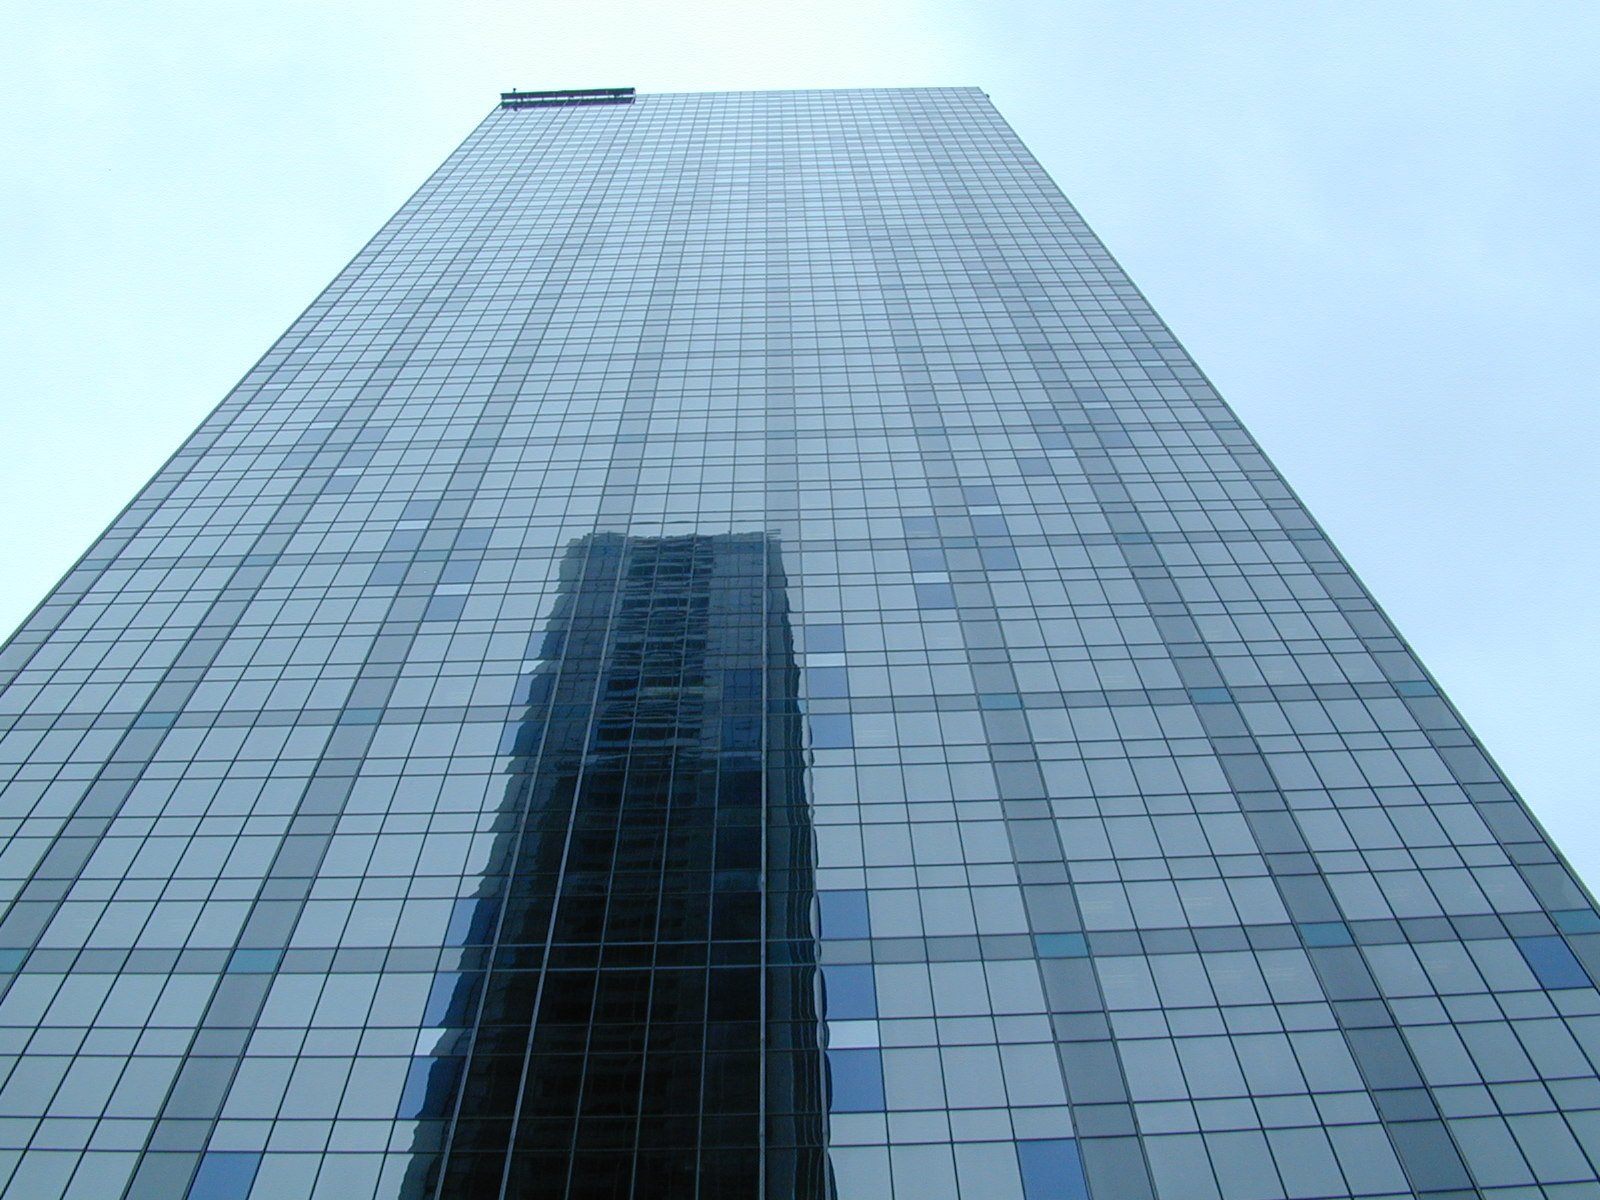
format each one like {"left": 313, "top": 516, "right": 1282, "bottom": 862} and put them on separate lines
{"left": 0, "top": 0, "right": 1600, "bottom": 880}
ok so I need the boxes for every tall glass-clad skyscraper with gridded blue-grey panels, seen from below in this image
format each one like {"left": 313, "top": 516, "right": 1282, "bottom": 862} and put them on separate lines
{"left": 0, "top": 80, "right": 1600, "bottom": 1200}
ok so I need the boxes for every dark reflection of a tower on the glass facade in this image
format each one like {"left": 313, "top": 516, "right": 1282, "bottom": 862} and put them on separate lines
{"left": 402, "top": 534, "right": 829, "bottom": 1200}
